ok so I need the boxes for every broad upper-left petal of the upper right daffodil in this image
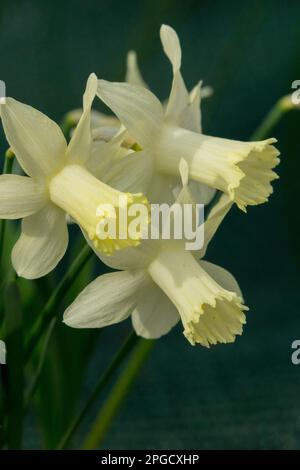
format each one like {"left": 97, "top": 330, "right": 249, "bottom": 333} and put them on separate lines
{"left": 97, "top": 80, "right": 163, "bottom": 148}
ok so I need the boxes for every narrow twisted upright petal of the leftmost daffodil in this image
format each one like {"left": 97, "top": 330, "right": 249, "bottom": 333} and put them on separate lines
{"left": 67, "top": 73, "right": 98, "bottom": 163}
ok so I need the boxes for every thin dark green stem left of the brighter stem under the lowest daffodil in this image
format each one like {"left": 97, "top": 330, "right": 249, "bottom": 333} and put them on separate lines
{"left": 57, "top": 332, "right": 140, "bottom": 449}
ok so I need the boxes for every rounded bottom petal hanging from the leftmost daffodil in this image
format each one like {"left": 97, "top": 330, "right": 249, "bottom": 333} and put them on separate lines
{"left": 12, "top": 204, "right": 68, "bottom": 279}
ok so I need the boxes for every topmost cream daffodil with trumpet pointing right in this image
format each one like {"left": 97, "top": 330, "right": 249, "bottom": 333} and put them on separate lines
{"left": 97, "top": 26, "right": 279, "bottom": 211}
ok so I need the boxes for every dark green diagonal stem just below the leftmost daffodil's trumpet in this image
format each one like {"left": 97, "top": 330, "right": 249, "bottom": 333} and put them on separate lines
{"left": 25, "top": 245, "right": 93, "bottom": 361}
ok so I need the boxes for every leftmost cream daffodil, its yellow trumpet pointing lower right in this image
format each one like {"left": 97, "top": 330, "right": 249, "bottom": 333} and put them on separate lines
{"left": 0, "top": 74, "right": 146, "bottom": 279}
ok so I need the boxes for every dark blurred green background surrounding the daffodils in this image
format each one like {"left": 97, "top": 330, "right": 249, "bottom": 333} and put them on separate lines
{"left": 0, "top": 0, "right": 300, "bottom": 449}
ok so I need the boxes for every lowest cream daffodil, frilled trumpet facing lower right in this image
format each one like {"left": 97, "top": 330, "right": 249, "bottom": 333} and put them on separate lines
{"left": 64, "top": 166, "right": 248, "bottom": 347}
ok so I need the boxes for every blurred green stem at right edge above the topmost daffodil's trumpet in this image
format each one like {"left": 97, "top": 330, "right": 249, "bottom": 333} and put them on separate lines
{"left": 251, "top": 95, "right": 299, "bottom": 141}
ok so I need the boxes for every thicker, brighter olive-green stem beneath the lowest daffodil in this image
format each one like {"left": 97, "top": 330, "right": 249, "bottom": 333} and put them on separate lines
{"left": 82, "top": 339, "right": 155, "bottom": 450}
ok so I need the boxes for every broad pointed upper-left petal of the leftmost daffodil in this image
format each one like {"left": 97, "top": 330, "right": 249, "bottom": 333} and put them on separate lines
{"left": 1, "top": 98, "right": 67, "bottom": 177}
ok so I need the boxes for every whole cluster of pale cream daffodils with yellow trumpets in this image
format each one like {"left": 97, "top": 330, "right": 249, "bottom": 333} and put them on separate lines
{"left": 0, "top": 25, "right": 279, "bottom": 347}
